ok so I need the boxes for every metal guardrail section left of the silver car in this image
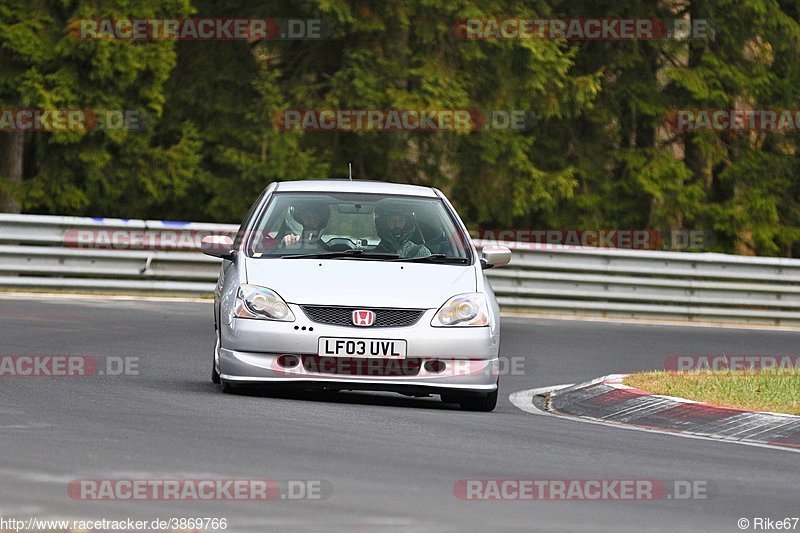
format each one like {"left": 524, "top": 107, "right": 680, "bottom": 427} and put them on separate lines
{"left": 0, "top": 214, "right": 233, "bottom": 295}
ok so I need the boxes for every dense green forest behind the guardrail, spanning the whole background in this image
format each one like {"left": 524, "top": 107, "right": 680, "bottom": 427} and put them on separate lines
{"left": 0, "top": 0, "right": 800, "bottom": 257}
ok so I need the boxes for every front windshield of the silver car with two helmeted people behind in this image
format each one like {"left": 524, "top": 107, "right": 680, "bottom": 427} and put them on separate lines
{"left": 247, "top": 193, "right": 470, "bottom": 264}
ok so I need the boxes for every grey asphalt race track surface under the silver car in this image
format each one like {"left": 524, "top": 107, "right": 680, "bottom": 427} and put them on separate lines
{"left": 0, "top": 299, "right": 800, "bottom": 532}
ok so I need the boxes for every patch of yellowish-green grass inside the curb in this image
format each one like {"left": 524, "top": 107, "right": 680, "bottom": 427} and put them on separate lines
{"left": 624, "top": 368, "right": 800, "bottom": 415}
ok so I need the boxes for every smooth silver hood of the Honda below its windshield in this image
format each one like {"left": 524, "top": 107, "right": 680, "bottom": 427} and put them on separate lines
{"left": 246, "top": 258, "right": 477, "bottom": 309}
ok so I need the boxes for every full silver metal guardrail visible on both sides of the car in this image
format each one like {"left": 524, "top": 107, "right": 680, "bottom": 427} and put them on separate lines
{"left": 0, "top": 214, "right": 800, "bottom": 325}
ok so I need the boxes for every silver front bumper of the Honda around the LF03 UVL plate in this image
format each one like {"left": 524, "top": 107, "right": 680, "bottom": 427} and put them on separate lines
{"left": 217, "top": 305, "right": 500, "bottom": 393}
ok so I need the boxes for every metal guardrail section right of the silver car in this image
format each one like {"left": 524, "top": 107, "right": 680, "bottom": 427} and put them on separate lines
{"left": 489, "top": 243, "right": 800, "bottom": 325}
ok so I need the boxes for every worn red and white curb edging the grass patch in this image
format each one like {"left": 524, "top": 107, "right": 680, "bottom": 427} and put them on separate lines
{"left": 509, "top": 374, "right": 800, "bottom": 452}
